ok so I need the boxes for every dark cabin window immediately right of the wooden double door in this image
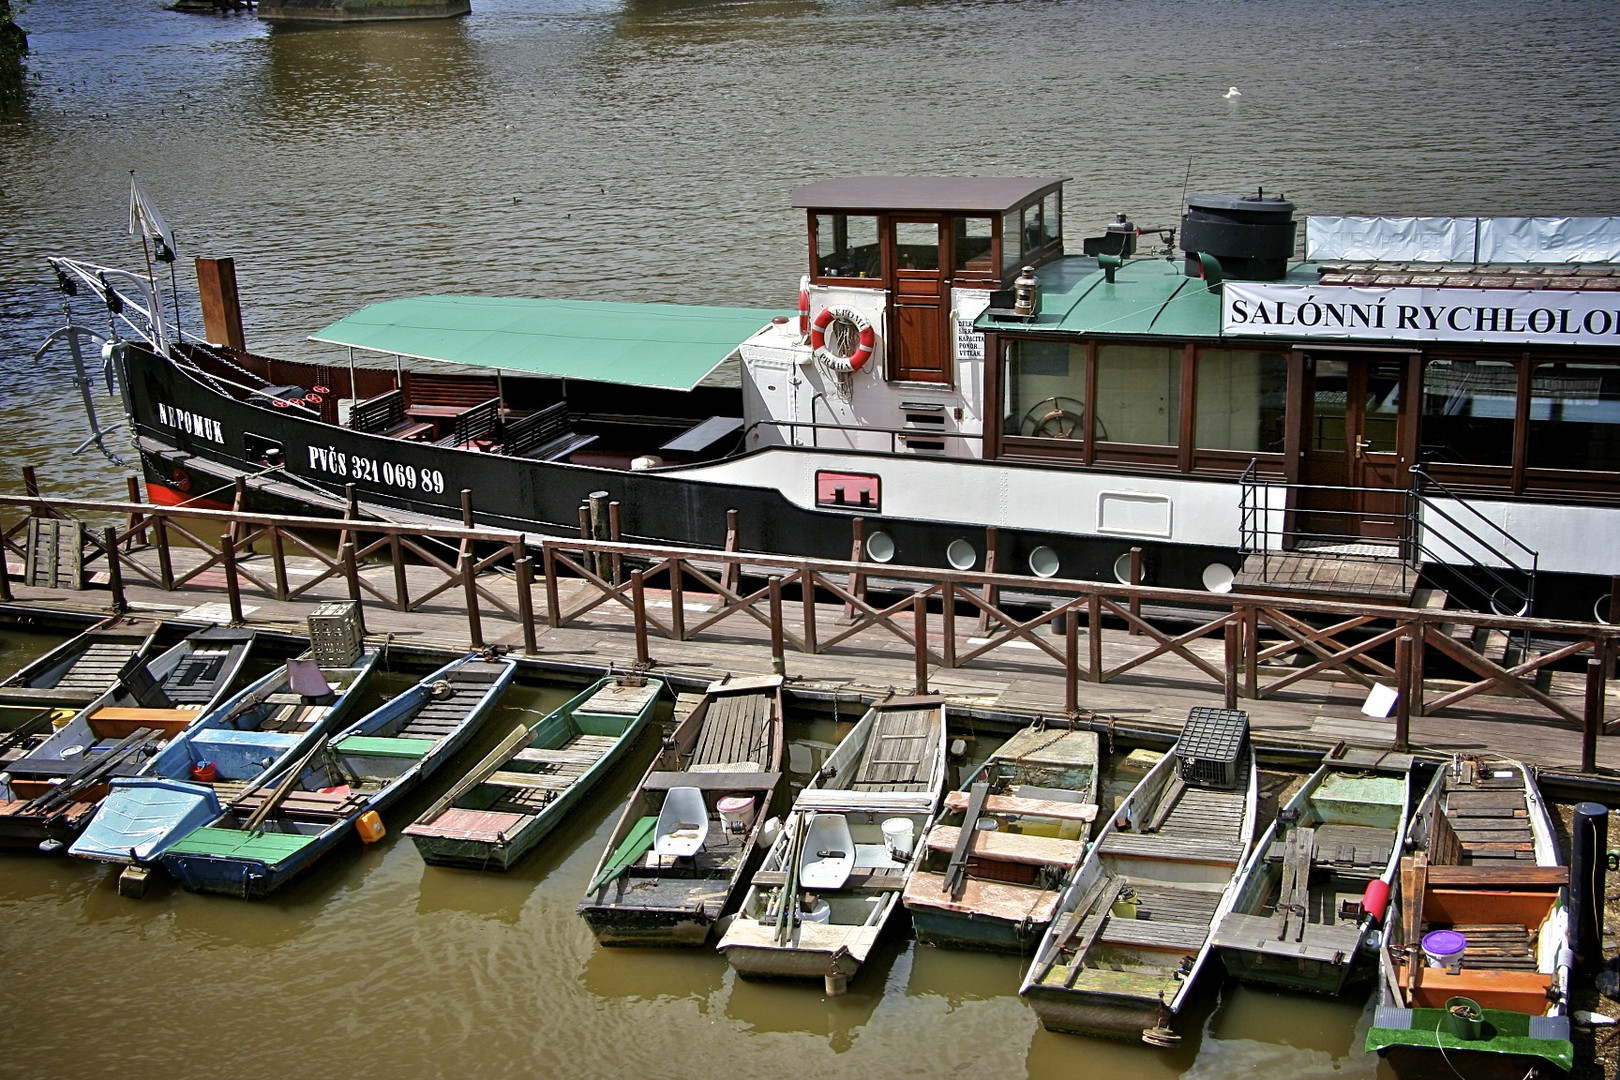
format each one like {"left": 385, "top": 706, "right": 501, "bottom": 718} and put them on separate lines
{"left": 1418, "top": 356, "right": 1518, "bottom": 466}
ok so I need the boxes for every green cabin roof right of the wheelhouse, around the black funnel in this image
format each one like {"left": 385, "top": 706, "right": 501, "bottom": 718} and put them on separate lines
{"left": 975, "top": 256, "right": 1317, "bottom": 340}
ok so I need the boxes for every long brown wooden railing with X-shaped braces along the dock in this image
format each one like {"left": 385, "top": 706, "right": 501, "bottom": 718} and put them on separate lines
{"left": 0, "top": 485, "right": 1620, "bottom": 771}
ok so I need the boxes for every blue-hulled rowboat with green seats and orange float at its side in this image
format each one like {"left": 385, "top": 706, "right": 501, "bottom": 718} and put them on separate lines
{"left": 162, "top": 653, "right": 517, "bottom": 897}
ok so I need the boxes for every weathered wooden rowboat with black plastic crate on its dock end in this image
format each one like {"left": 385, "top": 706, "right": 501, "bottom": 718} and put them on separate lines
{"left": 1019, "top": 709, "right": 1256, "bottom": 1044}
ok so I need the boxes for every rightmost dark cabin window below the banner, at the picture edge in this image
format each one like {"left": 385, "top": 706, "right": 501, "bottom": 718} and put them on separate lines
{"left": 1529, "top": 363, "right": 1620, "bottom": 473}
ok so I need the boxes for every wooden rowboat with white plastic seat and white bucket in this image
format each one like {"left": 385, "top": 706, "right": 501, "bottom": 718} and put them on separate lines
{"left": 719, "top": 698, "right": 944, "bottom": 993}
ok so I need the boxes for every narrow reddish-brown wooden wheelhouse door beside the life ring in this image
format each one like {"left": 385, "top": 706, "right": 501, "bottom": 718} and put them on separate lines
{"left": 888, "top": 215, "right": 951, "bottom": 382}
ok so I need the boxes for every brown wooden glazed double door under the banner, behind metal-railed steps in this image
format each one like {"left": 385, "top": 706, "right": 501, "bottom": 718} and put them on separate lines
{"left": 1296, "top": 353, "right": 1409, "bottom": 544}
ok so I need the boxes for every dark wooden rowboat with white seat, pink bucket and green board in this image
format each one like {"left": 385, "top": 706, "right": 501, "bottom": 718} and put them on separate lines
{"left": 580, "top": 675, "right": 782, "bottom": 946}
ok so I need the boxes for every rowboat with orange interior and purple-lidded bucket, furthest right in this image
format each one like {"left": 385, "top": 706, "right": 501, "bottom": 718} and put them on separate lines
{"left": 1366, "top": 758, "right": 1575, "bottom": 1080}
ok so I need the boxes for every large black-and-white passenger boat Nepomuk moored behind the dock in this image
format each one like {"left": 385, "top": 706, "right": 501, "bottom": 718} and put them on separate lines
{"left": 44, "top": 176, "right": 1620, "bottom": 620}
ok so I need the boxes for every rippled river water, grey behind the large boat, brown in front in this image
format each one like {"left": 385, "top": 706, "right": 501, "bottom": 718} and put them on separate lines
{"left": 0, "top": 0, "right": 1620, "bottom": 1078}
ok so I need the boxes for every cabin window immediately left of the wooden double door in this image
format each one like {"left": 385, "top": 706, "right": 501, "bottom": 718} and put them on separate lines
{"left": 1192, "top": 348, "right": 1288, "bottom": 453}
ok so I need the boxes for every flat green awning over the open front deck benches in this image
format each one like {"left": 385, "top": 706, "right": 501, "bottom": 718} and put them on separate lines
{"left": 311, "top": 296, "right": 791, "bottom": 390}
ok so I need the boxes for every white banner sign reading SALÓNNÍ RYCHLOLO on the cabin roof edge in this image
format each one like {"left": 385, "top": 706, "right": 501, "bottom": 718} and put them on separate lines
{"left": 1220, "top": 282, "right": 1620, "bottom": 345}
